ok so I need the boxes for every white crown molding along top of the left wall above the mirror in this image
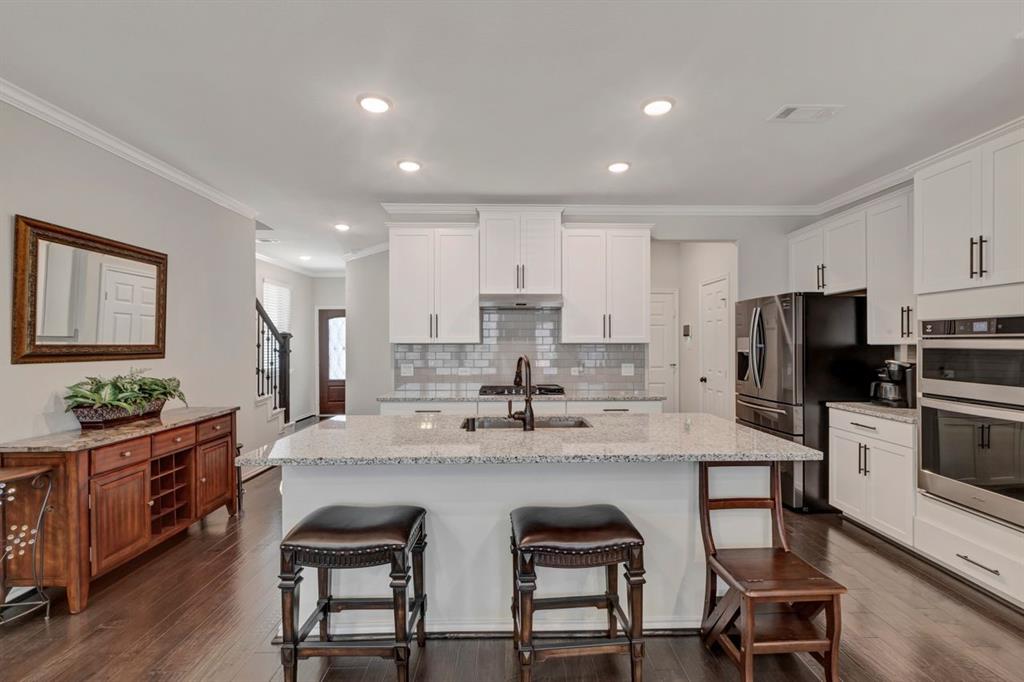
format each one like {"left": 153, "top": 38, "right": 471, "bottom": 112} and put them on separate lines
{"left": 0, "top": 78, "right": 257, "bottom": 220}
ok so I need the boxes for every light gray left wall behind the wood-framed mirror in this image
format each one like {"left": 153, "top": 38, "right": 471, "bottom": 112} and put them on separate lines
{"left": 0, "top": 102, "right": 266, "bottom": 446}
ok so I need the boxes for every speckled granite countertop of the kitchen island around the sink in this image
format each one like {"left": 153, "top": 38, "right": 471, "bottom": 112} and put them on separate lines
{"left": 236, "top": 414, "right": 821, "bottom": 466}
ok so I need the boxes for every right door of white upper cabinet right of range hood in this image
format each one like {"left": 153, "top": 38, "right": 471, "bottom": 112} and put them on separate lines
{"left": 605, "top": 229, "right": 650, "bottom": 343}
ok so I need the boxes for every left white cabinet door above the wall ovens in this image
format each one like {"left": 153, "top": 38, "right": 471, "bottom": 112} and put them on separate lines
{"left": 913, "top": 148, "right": 984, "bottom": 294}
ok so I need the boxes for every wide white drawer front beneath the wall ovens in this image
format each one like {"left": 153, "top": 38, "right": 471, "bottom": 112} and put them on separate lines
{"left": 913, "top": 517, "right": 1024, "bottom": 601}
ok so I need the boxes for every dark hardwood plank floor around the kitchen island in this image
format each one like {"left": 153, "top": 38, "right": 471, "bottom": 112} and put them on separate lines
{"left": 0, "top": 472, "right": 1024, "bottom": 682}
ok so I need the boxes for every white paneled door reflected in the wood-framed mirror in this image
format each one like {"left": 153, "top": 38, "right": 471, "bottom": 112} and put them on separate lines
{"left": 99, "top": 265, "right": 157, "bottom": 344}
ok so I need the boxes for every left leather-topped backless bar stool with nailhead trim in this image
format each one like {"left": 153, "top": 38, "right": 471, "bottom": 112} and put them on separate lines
{"left": 279, "top": 505, "right": 427, "bottom": 682}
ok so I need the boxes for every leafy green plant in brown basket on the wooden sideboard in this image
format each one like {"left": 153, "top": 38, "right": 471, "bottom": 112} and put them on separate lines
{"left": 63, "top": 370, "right": 187, "bottom": 428}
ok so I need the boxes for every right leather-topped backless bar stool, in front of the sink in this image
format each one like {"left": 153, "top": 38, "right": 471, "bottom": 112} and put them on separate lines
{"left": 511, "top": 505, "right": 644, "bottom": 682}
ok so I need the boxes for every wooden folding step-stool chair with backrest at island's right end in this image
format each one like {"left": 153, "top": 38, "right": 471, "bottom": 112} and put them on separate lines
{"left": 699, "top": 462, "right": 846, "bottom": 682}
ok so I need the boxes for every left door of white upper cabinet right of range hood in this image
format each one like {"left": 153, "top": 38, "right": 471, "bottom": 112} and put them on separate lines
{"left": 562, "top": 229, "right": 607, "bottom": 343}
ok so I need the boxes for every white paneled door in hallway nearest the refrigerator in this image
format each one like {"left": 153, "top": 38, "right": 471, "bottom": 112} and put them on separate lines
{"left": 699, "top": 275, "right": 735, "bottom": 419}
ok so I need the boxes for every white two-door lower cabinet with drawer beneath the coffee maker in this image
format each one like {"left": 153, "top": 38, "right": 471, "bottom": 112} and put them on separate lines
{"left": 828, "top": 410, "right": 916, "bottom": 545}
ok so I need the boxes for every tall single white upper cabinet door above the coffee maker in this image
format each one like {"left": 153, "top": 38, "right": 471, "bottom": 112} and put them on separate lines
{"left": 866, "top": 196, "right": 916, "bottom": 345}
